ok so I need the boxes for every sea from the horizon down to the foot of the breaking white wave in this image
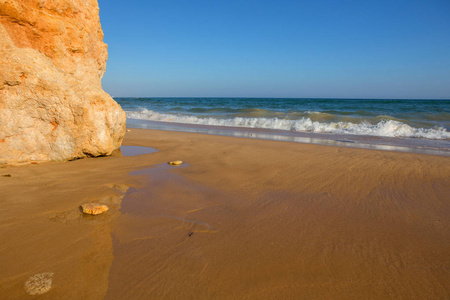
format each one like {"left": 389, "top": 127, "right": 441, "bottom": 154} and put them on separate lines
{"left": 115, "top": 98, "right": 450, "bottom": 140}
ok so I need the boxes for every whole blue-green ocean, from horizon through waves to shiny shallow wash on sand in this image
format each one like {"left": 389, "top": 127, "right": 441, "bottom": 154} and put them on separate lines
{"left": 114, "top": 97, "right": 450, "bottom": 155}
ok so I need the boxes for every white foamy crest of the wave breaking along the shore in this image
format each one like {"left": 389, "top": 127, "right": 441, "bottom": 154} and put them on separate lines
{"left": 126, "top": 109, "right": 450, "bottom": 139}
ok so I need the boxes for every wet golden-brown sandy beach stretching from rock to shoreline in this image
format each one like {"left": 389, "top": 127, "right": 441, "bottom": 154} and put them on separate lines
{"left": 0, "top": 128, "right": 450, "bottom": 299}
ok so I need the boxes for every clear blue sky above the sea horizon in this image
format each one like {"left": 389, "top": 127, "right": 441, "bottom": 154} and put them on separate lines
{"left": 99, "top": 0, "right": 450, "bottom": 99}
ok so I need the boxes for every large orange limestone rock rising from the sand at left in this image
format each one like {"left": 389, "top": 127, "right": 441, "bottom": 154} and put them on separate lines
{"left": 0, "top": 0, "right": 126, "bottom": 165}
